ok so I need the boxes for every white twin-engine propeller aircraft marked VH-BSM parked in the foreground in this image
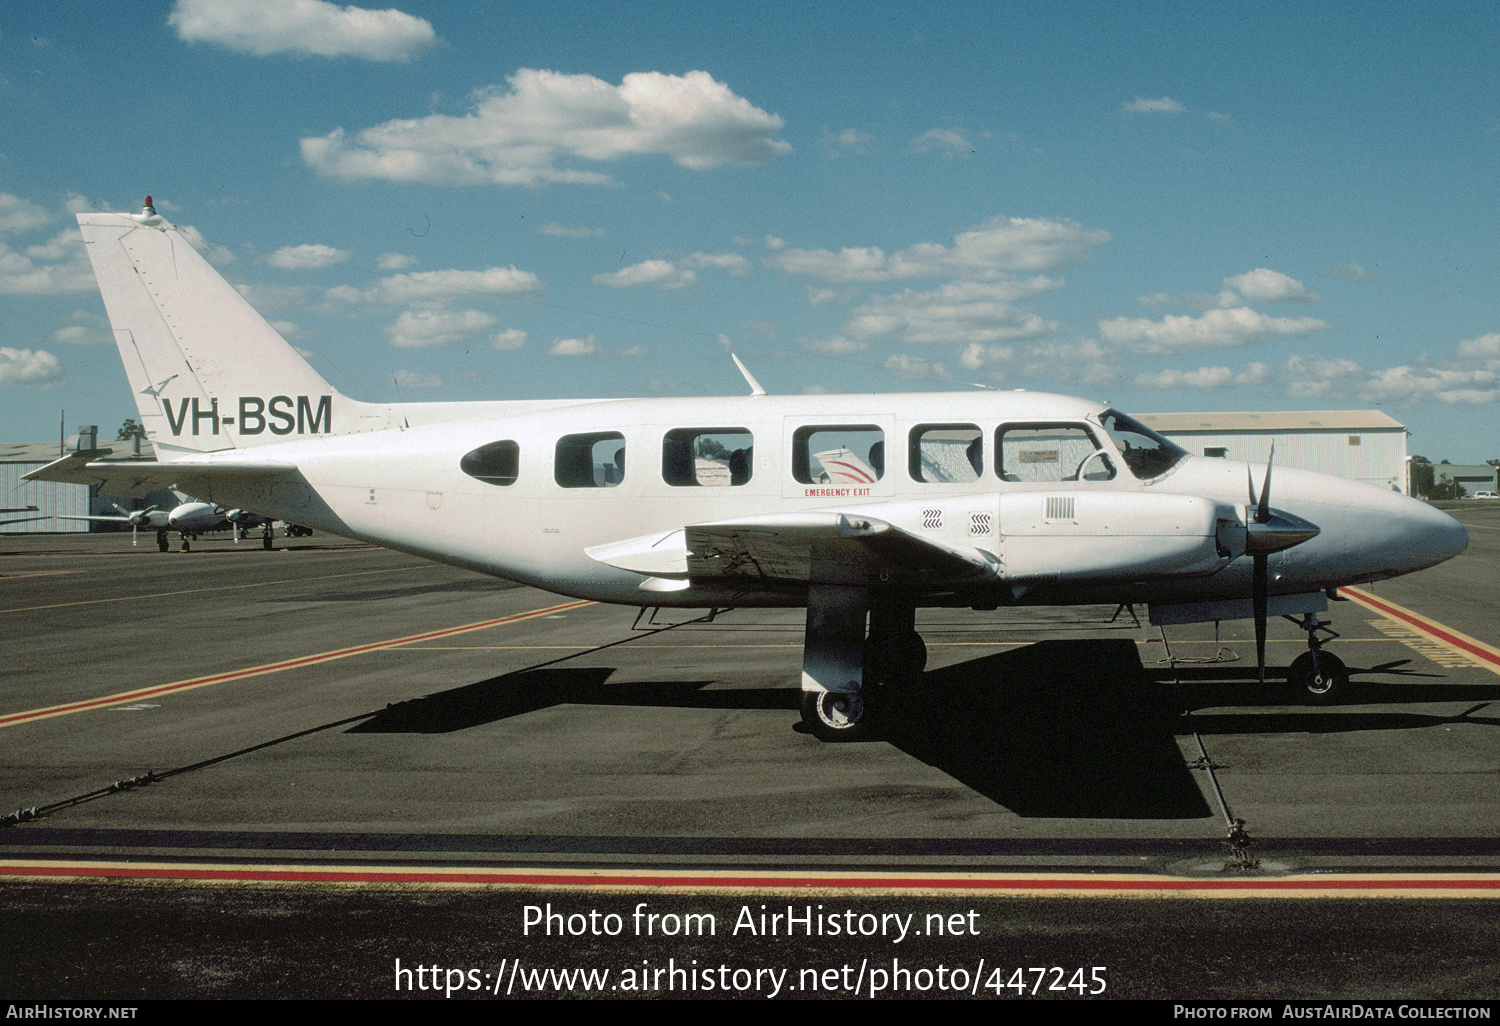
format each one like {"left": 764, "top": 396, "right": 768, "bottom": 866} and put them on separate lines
{"left": 29, "top": 197, "right": 1469, "bottom": 740}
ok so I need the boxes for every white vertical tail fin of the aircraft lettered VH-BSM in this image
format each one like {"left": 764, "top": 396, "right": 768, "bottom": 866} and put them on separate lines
{"left": 78, "top": 197, "right": 345, "bottom": 459}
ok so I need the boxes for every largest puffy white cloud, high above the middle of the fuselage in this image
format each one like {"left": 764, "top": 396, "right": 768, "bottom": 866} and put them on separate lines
{"left": 302, "top": 68, "right": 792, "bottom": 186}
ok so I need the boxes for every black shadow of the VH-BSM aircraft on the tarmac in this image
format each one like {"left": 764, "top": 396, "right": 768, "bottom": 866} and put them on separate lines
{"left": 350, "top": 639, "right": 1500, "bottom": 819}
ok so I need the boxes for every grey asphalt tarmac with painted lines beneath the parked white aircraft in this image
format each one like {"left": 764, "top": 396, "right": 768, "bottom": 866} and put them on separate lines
{"left": 0, "top": 507, "right": 1500, "bottom": 999}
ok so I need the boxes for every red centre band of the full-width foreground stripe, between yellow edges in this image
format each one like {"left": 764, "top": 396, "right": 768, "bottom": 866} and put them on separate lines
{"left": 0, "top": 863, "right": 1500, "bottom": 894}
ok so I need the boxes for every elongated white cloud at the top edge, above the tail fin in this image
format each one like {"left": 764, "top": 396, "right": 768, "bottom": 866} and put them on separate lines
{"left": 167, "top": 0, "right": 437, "bottom": 62}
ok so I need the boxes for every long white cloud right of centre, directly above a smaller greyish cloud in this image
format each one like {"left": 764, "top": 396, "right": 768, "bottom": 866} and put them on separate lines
{"left": 765, "top": 218, "right": 1110, "bottom": 280}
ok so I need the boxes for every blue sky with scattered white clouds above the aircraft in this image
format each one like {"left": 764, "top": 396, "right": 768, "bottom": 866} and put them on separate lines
{"left": 0, "top": 0, "right": 1500, "bottom": 462}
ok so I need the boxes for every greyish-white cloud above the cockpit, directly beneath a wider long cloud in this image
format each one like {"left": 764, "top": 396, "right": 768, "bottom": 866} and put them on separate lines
{"left": 843, "top": 282, "right": 1061, "bottom": 344}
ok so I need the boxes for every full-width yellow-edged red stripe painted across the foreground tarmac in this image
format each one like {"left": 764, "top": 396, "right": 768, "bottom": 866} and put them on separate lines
{"left": 0, "top": 858, "right": 1500, "bottom": 899}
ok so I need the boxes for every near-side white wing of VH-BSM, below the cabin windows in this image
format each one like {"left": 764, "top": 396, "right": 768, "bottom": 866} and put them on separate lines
{"left": 587, "top": 510, "right": 999, "bottom": 588}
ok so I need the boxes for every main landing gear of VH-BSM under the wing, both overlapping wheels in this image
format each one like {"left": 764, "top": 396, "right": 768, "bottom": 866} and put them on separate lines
{"left": 801, "top": 585, "right": 927, "bottom": 741}
